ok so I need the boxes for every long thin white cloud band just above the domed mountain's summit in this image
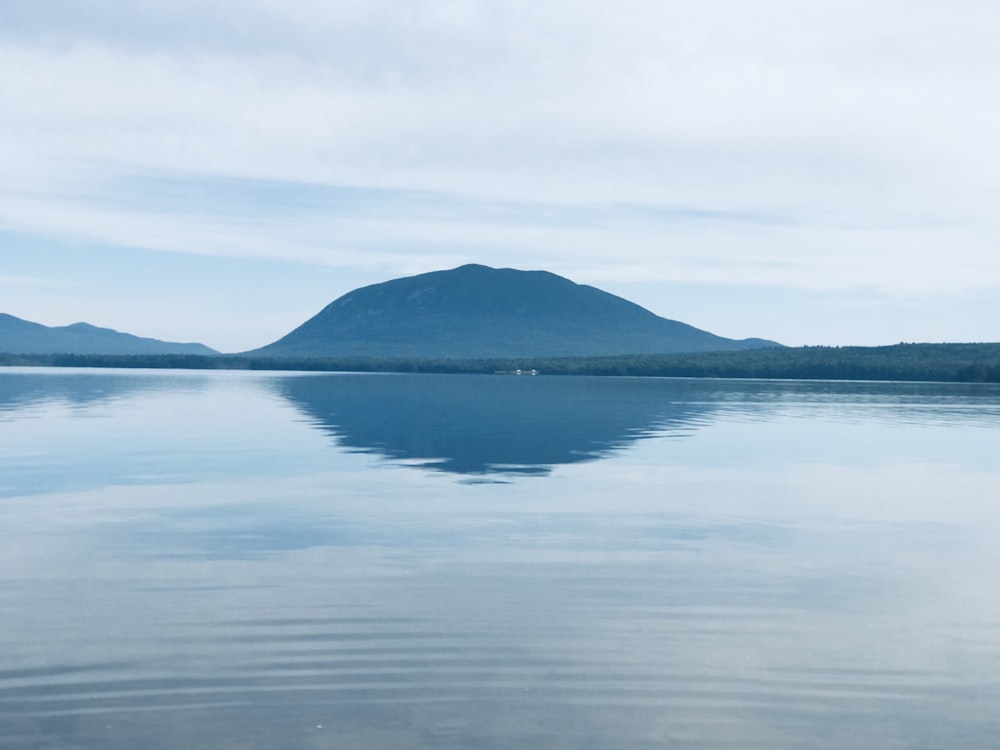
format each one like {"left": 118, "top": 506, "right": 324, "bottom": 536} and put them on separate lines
{"left": 0, "top": 164, "right": 1000, "bottom": 295}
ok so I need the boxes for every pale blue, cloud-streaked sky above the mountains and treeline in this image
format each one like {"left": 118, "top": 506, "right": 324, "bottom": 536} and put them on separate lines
{"left": 0, "top": 0, "right": 1000, "bottom": 352}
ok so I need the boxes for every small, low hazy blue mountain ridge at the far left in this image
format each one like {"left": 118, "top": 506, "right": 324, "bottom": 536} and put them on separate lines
{"left": 0, "top": 313, "right": 218, "bottom": 354}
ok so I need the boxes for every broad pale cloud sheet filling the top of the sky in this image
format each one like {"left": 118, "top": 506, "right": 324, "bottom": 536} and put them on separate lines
{"left": 3, "top": 2, "right": 997, "bottom": 194}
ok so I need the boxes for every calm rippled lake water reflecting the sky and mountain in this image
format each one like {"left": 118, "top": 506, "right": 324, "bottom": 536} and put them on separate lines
{"left": 0, "top": 368, "right": 1000, "bottom": 750}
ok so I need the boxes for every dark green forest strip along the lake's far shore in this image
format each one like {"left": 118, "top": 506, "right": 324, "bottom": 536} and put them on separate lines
{"left": 0, "top": 343, "right": 1000, "bottom": 383}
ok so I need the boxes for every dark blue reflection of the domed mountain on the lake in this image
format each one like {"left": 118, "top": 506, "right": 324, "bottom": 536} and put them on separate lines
{"left": 273, "top": 374, "right": 713, "bottom": 474}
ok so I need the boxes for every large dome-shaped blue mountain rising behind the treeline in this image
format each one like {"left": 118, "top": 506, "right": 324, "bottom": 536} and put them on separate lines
{"left": 246, "top": 265, "right": 780, "bottom": 359}
